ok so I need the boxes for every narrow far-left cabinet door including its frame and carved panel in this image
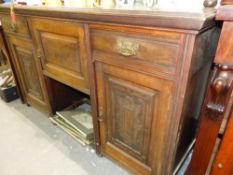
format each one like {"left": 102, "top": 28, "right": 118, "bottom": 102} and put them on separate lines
{"left": 8, "top": 36, "right": 48, "bottom": 111}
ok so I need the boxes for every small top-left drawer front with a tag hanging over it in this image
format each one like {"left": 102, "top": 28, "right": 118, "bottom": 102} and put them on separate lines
{"left": 0, "top": 14, "right": 30, "bottom": 37}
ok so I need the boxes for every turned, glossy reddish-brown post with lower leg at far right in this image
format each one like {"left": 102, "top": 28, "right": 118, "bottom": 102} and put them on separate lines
{"left": 186, "top": 65, "right": 233, "bottom": 175}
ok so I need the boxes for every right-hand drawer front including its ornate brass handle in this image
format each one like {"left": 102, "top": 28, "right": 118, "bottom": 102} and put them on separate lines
{"left": 91, "top": 27, "right": 183, "bottom": 74}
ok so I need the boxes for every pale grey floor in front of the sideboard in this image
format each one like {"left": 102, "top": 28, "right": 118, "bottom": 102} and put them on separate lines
{"left": 0, "top": 99, "right": 189, "bottom": 175}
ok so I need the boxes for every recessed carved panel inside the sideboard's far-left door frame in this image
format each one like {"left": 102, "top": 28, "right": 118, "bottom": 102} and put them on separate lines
{"left": 15, "top": 46, "right": 43, "bottom": 100}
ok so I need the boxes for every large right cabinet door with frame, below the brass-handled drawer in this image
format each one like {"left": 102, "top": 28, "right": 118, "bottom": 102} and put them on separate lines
{"left": 96, "top": 62, "right": 173, "bottom": 175}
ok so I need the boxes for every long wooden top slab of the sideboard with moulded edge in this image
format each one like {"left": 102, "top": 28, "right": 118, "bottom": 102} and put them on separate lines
{"left": 0, "top": 4, "right": 216, "bottom": 30}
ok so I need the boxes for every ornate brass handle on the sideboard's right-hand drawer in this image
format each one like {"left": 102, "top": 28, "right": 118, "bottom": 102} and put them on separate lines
{"left": 117, "top": 40, "right": 139, "bottom": 56}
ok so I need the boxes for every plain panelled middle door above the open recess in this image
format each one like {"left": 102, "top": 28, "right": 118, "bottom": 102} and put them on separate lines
{"left": 30, "top": 18, "right": 90, "bottom": 94}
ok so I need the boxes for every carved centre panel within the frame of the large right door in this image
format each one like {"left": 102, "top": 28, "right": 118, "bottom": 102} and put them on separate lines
{"left": 106, "top": 77, "right": 157, "bottom": 162}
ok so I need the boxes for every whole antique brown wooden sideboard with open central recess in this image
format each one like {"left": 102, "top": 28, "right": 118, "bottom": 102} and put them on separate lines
{"left": 0, "top": 5, "right": 219, "bottom": 175}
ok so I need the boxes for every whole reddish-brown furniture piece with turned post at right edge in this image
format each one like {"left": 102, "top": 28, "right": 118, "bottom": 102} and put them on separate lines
{"left": 186, "top": 6, "right": 233, "bottom": 175}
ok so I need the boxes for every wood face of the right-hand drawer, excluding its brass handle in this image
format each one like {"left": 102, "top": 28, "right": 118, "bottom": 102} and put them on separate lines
{"left": 92, "top": 29, "right": 182, "bottom": 74}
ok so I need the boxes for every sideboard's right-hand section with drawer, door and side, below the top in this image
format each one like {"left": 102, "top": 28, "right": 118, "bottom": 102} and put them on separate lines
{"left": 90, "top": 25, "right": 219, "bottom": 174}
